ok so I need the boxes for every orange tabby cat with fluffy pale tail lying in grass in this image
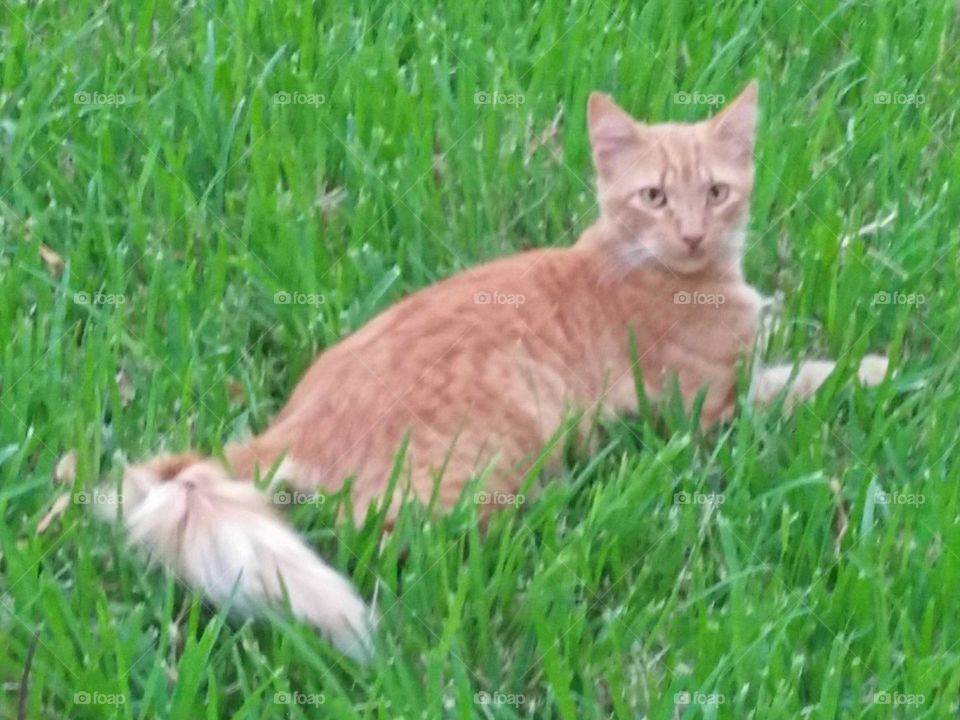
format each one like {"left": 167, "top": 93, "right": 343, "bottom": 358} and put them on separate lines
{"left": 110, "top": 83, "right": 886, "bottom": 657}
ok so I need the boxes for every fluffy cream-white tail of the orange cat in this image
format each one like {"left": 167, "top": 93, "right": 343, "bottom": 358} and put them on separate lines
{"left": 105, "top": 455, "right": 375, "bottom": 661}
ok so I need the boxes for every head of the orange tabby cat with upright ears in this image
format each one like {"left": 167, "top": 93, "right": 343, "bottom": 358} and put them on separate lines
{"left": 587, "top": 81, "right": 757, "bottom": 274}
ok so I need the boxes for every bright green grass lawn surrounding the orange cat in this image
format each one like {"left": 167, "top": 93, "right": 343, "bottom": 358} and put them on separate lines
{"left": 0, "top": 0, "right": 960, "bottom": 720}
